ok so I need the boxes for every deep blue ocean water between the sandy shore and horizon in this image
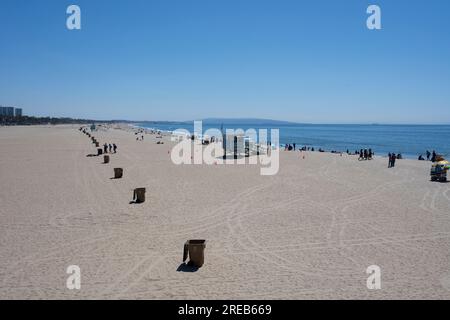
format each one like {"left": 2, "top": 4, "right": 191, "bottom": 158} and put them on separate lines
{"left": 136, "top": 122, "right": 450, "bottom": 159}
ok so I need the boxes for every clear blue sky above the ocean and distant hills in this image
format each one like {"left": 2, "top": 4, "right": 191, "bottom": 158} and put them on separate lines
{"left": 0, "top": 0, "right": 450, "bottom": 123}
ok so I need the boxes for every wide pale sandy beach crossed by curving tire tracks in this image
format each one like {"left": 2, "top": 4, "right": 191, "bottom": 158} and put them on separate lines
{"left": 0, "top": 126, "right": 450, "bottom": 299}
